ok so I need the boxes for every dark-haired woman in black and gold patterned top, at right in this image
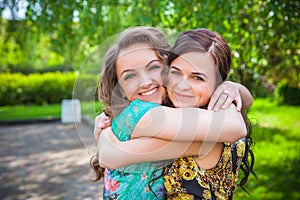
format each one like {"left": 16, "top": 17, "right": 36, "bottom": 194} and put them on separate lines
{"left": 164, "top": 29, "right": 254, "bottom": 199}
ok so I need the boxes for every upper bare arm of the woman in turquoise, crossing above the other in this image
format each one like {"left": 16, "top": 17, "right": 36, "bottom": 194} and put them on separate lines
{"left": 132, "top": 105, "right": 247, "bottom": 142}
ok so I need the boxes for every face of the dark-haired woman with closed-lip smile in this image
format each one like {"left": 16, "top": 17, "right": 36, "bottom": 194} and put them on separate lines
{"left": 168, "top": 52, "right": 216, "bottom": 107}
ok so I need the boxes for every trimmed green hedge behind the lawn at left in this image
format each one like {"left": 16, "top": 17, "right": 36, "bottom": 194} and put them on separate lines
{"left": 0, "top": 72, "right": 97, "bottom": 106}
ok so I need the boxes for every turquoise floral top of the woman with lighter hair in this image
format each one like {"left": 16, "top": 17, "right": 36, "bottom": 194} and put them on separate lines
{"left": 103, "top": 100, "right": 165, "bottom": 200}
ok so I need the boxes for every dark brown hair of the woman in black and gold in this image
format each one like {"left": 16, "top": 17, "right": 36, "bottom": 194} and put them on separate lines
{"left": 168, "top": 28, "right": 256, "bottom": 192}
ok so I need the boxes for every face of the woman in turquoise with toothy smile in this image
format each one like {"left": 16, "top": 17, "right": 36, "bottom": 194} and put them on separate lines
{"left": 116, "top": 44, "right": 165, "bottom": 104}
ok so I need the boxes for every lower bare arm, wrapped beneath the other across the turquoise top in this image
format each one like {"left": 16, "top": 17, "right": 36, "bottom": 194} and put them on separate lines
{"left": 98, "top": 128, "right": 207, "bottom": 169}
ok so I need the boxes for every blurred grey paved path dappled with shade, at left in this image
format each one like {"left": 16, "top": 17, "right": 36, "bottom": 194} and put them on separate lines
{"left": 0, "top": 122, "right": 103, "bottom": 200}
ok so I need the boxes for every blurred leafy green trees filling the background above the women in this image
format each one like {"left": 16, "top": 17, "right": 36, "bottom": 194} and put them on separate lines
{"left": 0, "top": 0, "right": 300, "bottom": 103}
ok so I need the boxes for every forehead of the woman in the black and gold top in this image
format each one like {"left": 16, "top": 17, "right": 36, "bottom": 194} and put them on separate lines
{"left": 171, "top": 52, "right": 216, "bottom": 73}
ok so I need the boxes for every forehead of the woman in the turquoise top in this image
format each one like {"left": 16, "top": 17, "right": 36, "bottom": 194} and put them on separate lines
{"left": 116, "top": 44, "right": 159, "bottom": 72}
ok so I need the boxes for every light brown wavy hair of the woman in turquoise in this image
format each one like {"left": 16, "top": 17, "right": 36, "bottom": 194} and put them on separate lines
{"left": 90, "top": 27, "right": 170, "bottom": 182}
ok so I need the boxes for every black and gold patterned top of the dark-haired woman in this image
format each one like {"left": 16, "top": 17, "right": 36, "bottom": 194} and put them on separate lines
{"left": 164, "top": 139, "right": 245, "bottom": 199}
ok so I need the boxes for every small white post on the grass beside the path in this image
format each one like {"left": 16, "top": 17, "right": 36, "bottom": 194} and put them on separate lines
{"left": 61, "top": 99, "right": 81, "bottom": 123}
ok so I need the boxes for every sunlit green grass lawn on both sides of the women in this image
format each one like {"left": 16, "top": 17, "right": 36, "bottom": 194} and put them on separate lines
{"left": 0, "top": 99, "right": 300, "bottom": 200}
